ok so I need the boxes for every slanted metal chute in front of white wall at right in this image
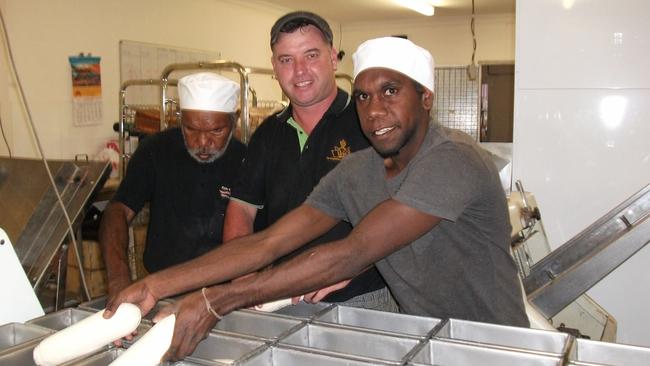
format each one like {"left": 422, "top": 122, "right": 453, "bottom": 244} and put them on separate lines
{"left": 524, "top": 184, "right": 650, "bottom": 318}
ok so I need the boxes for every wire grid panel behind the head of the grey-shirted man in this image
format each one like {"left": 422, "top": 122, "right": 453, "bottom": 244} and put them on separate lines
{"left": 433, "top": 66, "right": 479, "bottom": 141}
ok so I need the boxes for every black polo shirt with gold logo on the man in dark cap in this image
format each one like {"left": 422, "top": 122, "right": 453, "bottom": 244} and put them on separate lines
{"left": 232, "top": 89, "right": 386, "bottom": 302}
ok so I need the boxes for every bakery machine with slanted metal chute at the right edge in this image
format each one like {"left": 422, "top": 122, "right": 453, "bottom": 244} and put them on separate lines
{"left": 508, "top": 182, "right": 650, "bottom": 341}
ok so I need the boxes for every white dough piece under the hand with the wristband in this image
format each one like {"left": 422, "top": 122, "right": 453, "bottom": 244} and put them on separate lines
{"left": 109, "top": 314, "right": 176, "bottom": 366}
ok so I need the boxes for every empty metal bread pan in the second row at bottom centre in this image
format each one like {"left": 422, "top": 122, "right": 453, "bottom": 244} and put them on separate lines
{"left": 280, "top": 324, "right": 418, "bottom": 362}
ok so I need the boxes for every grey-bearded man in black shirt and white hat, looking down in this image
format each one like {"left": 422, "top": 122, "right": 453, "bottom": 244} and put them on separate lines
{"left": 99, "top": 73, "right": 245, "bottom": 297}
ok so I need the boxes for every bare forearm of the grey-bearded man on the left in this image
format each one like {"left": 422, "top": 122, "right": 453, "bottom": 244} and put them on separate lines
{"left": 98, "top": 202, "right": 135, "bottom": 297}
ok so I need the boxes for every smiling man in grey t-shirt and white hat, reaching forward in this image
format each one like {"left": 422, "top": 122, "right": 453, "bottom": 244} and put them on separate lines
{"left": 108, "top": 37, "right": 529, "bottom": 359}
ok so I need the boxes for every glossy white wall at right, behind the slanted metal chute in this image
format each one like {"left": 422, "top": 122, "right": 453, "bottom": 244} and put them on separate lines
{"left": 513, "top": 0, "right": 650, "bottom": 346}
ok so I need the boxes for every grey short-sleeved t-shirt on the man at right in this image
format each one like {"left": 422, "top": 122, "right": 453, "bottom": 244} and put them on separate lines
{"left": 306, "top": 123, "right": 528, "bottom": 326}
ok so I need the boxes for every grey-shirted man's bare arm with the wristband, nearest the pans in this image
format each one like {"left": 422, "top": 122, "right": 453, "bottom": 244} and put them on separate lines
{"left": 156, "top": 200, "right": 441, "bottom": 360}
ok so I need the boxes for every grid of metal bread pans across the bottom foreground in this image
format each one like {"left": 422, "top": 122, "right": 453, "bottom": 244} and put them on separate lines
{"left": 0, "top": 299, "right": 650, "bottom": 366}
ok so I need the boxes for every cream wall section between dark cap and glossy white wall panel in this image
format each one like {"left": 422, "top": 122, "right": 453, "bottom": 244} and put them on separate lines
{"left": 335, "top": 14, "right": 515, "bottom": 74}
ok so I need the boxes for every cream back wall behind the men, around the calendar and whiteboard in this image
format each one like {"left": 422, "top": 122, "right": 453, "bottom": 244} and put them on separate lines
{"left": 0, "top": 0, "right": 514, "bottom": 159}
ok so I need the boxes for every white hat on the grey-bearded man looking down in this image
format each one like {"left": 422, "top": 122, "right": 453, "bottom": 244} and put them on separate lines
{"left": 178, "top": 72, "right": 239, "bottom": 113}
